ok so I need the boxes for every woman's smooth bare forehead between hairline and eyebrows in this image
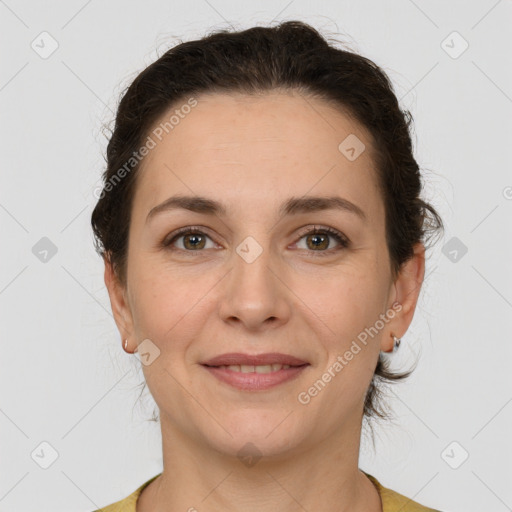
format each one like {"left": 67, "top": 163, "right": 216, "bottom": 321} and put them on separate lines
{"left": 134, "top": 91, "right": 382, "bottom": 220}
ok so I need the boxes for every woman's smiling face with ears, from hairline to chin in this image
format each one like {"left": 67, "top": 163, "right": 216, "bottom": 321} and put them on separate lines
{"left": 105, "top": 92, "right": 423, "bottom": 455}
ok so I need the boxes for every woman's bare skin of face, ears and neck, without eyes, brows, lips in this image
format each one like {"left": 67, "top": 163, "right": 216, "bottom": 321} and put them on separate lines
{"left": 105, "top": 91, "right": 425, "bottom": 512}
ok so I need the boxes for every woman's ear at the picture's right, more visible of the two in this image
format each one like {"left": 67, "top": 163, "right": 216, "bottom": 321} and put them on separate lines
{"left": 381, "top": 242, "right": 425, "bottom": 352}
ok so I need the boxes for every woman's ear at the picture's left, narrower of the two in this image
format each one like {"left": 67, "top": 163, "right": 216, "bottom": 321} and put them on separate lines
{"left": 103, "top": 256, "right": 137, "bottom": 352}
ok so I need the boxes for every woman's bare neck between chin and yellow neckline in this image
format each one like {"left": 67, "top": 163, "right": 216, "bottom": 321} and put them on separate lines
{"left": 137, "top": 417, "right": 382, "bottom": 512}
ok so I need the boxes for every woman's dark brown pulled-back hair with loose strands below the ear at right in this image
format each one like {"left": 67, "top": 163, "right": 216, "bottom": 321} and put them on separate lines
{"left": 91, "top": 21, "right": 443, "bottom": 436}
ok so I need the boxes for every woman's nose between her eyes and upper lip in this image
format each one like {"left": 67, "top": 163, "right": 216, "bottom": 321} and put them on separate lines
{"left": 219, "top": 242, "right": 293, "bottom": 331}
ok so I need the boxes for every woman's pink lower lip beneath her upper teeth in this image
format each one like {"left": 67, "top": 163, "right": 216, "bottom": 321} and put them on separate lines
{"left": 203, "top": 365, "right": 309, "bottom": 391}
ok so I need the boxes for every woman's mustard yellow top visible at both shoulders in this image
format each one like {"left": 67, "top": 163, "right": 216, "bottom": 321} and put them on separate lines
{"left": 94, "top": 471, "right": 440, "bottom": 512}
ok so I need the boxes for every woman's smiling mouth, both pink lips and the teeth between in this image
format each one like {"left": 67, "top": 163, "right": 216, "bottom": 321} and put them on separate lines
{"left": 201, "top": 353, "right": 310, "bottom": 391}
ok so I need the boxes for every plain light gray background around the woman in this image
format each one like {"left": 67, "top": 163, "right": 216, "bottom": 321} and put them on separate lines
{"left": 0, "top": 0, "right": 512, "bottom": 512}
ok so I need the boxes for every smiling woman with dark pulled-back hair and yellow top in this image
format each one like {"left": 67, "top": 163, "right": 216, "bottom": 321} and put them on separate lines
{"left": 92, "top": 22, "right": 442, "bottom": 512}
